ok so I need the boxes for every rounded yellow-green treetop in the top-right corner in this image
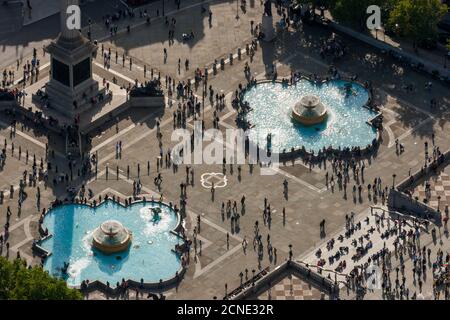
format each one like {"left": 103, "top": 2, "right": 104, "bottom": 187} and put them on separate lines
{"left": 388, "top": 0, "right": 447, "bottom": 45}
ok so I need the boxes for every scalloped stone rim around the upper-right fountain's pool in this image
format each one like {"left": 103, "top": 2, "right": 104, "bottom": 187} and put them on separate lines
{"left": 240, "top": 74, "right": 382, "bottom": 163}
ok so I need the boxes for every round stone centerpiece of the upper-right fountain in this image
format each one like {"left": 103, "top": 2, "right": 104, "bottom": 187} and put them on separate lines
{"left": 292, "top": 95, "right": 328, "bottom": 126}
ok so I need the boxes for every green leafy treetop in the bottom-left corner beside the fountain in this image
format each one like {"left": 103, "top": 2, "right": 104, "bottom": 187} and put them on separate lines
{"left": 0, "top": 257, "right": 83, "bottom": 300}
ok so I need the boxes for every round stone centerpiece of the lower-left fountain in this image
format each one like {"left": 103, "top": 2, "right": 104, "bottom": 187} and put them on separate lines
{"left": 92, "top": 220, "right": 132, "bottom": 254}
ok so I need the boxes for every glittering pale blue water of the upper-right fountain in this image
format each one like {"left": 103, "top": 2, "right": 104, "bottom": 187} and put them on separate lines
{"left": 243, "top": 79, "right": 376, "bottom": 152}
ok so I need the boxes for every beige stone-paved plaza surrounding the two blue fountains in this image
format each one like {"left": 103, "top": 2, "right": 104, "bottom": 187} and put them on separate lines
{"left": 0, "top": 0, "right": 450, "bottom": 300}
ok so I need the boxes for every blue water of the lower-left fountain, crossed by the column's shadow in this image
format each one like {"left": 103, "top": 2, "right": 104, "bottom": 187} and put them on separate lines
{"left": 41, "top": 201, "right": 182, "bottom": 286}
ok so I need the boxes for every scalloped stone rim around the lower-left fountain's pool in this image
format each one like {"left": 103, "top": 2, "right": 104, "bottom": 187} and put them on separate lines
{"left": 36, "top": 197, "right": 186, "bottom": 290}
